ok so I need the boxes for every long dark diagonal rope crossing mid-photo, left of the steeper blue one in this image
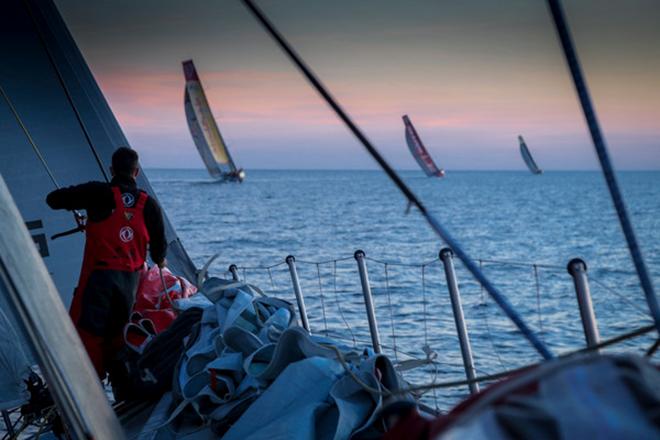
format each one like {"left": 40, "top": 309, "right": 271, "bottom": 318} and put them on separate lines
{"left": 242, "top": 0, "right": 554, "bottom": 359}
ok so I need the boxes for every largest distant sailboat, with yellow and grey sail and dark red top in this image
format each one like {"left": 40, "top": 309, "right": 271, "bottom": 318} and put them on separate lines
{"left": 183, "top": 60, "right": 245, "bottom": 182}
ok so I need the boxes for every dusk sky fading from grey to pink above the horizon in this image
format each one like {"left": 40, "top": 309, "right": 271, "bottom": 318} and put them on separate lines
{"left": 56, "top": 0, "right": 660, "bottom": 170}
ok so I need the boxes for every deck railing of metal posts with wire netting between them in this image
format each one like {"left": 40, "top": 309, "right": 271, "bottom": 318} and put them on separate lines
{"left": 225, "top": 248, "right": 650, "bottom": 408}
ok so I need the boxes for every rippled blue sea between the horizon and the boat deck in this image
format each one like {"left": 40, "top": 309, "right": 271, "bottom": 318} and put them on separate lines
{"left": 147, "top": 170, "right": 660, "bottom": 409}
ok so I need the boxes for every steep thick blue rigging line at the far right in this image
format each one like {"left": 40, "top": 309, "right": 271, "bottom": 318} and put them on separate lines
{"left": 548, "top": 0, "right": 660, "bottom": 333}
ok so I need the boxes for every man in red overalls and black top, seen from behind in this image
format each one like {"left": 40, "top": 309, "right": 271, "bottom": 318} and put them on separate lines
{"left": 46, "top": 147, "right": 167, "bottom": 379}
